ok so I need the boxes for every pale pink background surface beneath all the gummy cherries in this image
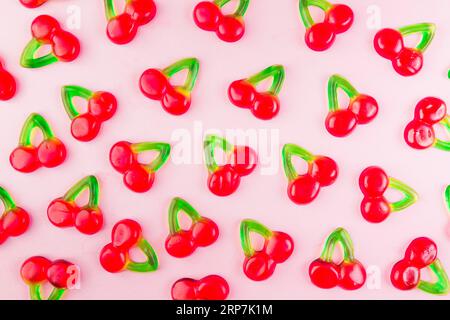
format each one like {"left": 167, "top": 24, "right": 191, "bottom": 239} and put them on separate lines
{"left": 0, "top": 0, "right": 450, "bottom": 299}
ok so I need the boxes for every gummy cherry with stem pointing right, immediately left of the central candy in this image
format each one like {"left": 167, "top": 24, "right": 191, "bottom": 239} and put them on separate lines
{"left": 109, "top": 141, "right": 170, "bottom": 192}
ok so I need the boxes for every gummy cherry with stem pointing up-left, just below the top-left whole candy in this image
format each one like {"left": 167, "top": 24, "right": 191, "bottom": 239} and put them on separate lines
{"left": 61, "top": 86, "right": 117, "bottom": 141}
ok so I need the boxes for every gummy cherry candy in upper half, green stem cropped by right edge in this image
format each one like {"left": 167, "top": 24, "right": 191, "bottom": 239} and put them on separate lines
{"left": 404, "top": 97, "right": 450, "bottom": 151}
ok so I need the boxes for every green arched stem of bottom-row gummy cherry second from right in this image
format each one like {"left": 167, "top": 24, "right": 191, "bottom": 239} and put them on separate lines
{"left": 320, "top": 228, "right": 355, "bottom": 262}
